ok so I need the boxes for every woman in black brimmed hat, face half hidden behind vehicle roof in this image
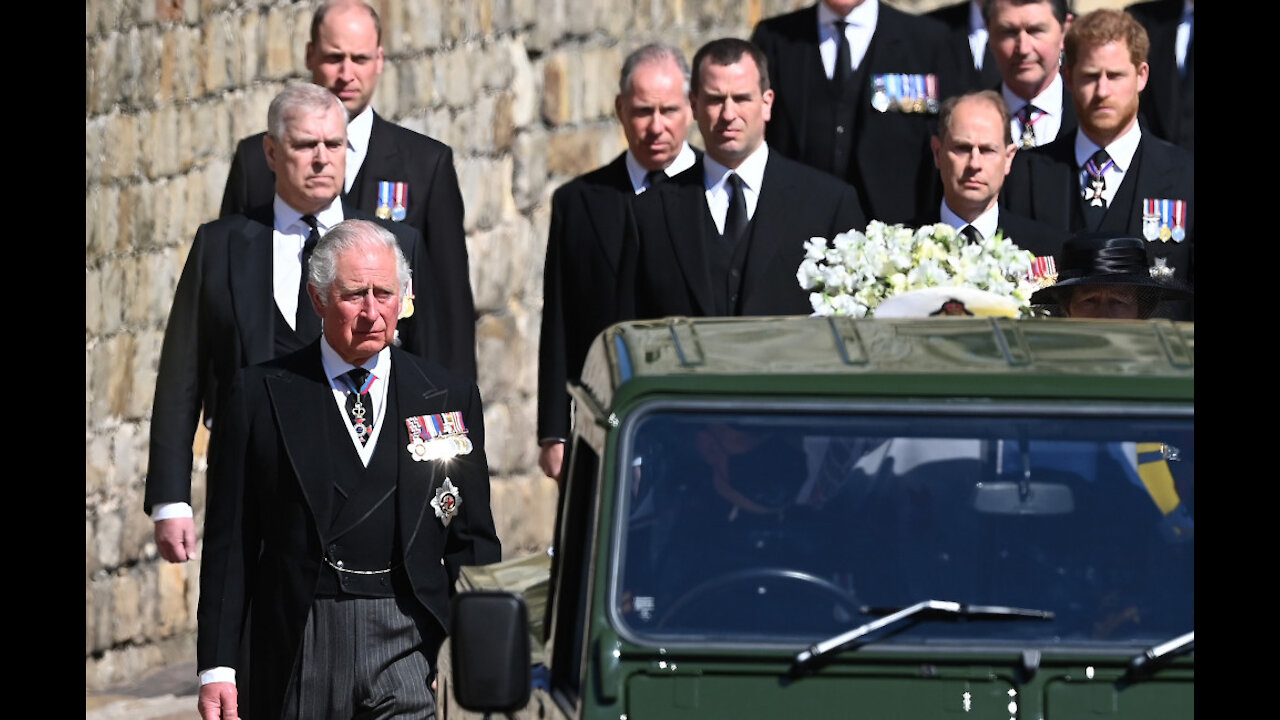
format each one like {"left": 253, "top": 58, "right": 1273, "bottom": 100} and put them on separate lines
{"left": 1032, "top": 233, "right": 1192, "bottom": 319}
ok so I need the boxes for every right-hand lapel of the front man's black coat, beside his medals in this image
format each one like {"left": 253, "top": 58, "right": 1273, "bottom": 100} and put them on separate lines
{"left": 391, "top": 347, "right": 453, "bottom": 555}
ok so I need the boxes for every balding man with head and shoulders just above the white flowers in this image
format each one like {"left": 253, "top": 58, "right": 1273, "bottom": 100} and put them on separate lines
{"left": 916, "top": 90, "right": 1069, "bottom": 256}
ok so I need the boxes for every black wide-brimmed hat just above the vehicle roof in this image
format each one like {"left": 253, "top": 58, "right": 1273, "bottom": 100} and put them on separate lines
{"left": 1032, "top": 233, "right": 1192, "bottom": 305}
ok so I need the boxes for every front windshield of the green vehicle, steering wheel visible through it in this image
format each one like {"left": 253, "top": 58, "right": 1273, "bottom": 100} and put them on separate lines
{"left": 611, "top": 407, "right": 1194, "bottom": 647}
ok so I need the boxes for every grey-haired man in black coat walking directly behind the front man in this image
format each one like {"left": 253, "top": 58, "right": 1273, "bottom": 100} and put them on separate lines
{"left": 143, "top": 83, "right": 438, "bottom": 562}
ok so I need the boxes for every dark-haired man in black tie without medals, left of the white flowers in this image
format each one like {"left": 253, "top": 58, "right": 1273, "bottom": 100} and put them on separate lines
{"left": 620, "top": 37, "right": 867, "bottom": 318}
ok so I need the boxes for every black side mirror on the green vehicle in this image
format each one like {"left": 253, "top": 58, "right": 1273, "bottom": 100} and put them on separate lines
{"left": 449, "top": 591, "right": 532, "bottom": 714}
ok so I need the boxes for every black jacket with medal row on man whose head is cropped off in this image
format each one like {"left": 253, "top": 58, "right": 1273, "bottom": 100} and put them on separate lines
{"left": 751, "top": 3, "right": 972, "bottom": 222}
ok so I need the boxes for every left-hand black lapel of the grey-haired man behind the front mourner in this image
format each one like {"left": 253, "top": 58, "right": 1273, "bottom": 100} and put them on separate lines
{"left": 227, "top": 206, "right": 276, "bottom": 365}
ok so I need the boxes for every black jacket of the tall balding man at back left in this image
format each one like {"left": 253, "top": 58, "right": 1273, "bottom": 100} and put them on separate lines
{"left": 221, "top": 113, "right": 476, "bottom": 379}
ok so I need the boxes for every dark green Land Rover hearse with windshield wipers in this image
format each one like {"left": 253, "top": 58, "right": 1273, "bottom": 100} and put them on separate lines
{"left": 438, "top": 318, "right": 1196, "bottom": 720}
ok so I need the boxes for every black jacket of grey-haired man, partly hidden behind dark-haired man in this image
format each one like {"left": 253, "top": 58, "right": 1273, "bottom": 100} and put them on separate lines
{"left": 538, "top": 150, "right": 701, "bottom": 439}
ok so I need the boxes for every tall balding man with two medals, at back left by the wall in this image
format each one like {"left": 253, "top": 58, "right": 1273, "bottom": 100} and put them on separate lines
{"left": 221, "top": 0, "right": 476, "bottom": 379}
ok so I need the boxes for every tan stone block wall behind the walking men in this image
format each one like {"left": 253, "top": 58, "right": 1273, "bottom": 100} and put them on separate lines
{"left": 84, "top": 0, "right": 1121, "bottom": 689}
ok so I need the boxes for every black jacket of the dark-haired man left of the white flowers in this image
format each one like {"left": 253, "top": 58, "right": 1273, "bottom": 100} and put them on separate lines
{"left": 621, "top": 149, "right": 867, "bottom": 318}
